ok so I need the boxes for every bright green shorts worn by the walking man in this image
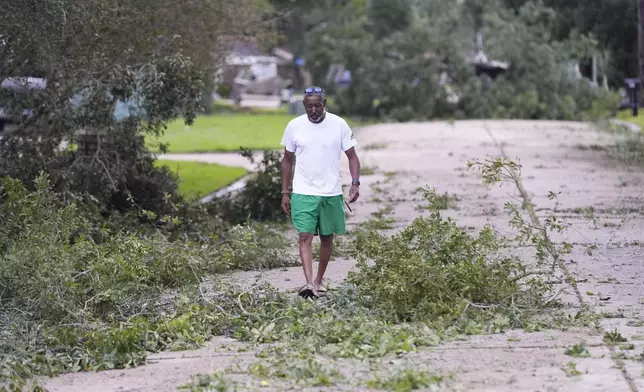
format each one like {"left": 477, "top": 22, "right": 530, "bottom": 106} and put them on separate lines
{"left": 291, "top": 193, "right": 347, "bottom": 235}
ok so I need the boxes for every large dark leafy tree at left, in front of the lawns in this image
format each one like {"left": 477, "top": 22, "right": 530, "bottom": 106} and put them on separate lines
{"left": 0, "top": 0, "right": 270, "bottom": 214}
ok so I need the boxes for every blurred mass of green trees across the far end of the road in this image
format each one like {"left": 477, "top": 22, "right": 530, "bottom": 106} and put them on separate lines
{"left": 270, "top": 0, "right": 624, "bottom": 120}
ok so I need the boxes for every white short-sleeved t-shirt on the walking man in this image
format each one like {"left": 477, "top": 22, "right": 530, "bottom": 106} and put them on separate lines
{"left": 282, "top": 112, "right": 357, "bottom": 196}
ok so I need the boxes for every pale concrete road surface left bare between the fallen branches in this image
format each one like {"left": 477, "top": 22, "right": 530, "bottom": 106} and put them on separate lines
{"left": 47, "top": 121, "right": 644, "bottom": 392}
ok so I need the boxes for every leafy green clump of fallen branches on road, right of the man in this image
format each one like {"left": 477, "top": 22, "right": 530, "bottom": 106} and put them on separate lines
{"left": 349, "top": 212, "right": 525, "bottom": 321}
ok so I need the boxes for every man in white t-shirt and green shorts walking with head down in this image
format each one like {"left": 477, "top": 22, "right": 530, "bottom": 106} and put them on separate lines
{"left": 281, "top": 87, "right": 360, "bottom": 298}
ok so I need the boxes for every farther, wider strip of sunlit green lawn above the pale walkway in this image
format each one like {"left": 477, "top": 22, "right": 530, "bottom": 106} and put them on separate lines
{"left": 147, "top": 114, "right": 295, "bottom": 153}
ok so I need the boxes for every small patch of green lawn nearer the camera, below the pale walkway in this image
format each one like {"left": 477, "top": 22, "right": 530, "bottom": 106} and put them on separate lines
{"left": 155, "top": 160, "right": 246, "bottom": 199}
